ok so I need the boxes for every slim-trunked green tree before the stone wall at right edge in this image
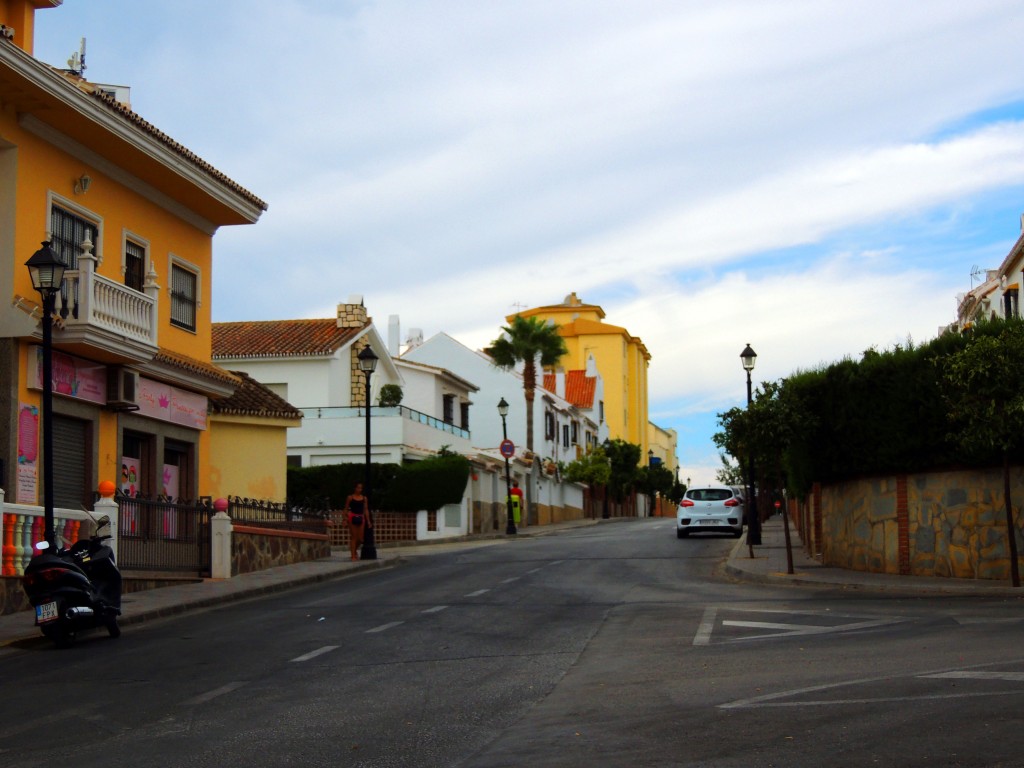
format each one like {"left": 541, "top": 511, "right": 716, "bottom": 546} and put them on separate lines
{"left": 942, "top": 321, "right": 1024, "bottom": 587}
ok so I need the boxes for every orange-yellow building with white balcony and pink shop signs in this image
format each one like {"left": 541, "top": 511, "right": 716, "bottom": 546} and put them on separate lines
{"left": 0, "top": 0, "right": 266, "bottom": 509}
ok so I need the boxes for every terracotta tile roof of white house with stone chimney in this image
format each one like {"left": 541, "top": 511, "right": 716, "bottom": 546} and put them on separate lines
{"left": 213, "top": 317, "right": 364, "bottom": 360}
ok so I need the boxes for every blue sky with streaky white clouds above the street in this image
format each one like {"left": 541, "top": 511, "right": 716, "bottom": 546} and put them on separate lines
{"left": 35, "top": 0, "right": 1024, "bottom": 483}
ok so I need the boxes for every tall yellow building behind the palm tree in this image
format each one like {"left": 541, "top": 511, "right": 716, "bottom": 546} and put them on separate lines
{"left": 516, "top": 293, "right": 650, "bottom": 457}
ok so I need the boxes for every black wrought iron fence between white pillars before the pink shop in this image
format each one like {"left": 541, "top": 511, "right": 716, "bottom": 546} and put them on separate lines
{"left": 115, "top": 494, "right": 214, "bottom": 574}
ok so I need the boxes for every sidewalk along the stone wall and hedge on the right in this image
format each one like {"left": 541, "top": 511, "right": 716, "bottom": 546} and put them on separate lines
{"left": 725, "top": 515, "right": 1024, "bottom": 598}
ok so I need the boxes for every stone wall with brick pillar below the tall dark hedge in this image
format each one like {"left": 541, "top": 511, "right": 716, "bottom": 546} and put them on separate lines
{"left": 815, "top": 467, "right": 1024, "bottom": 580}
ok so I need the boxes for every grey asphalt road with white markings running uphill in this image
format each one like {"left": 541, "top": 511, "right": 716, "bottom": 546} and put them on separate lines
{"left": 0, "top": 519, "right": 1024, "bottom": 768}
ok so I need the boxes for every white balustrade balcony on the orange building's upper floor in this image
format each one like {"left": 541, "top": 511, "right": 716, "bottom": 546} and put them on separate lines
{"left": 53, "top": 249, "right": 160, "bottom": 362}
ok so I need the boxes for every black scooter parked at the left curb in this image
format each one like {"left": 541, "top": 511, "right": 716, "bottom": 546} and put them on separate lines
{"left": 22, "top": 515, "right": 121, "bottom": 647}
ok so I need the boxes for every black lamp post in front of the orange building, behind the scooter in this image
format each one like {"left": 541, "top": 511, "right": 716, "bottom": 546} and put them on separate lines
{"left": 25, "top": 241, "right": 68, "bottom": 547}
